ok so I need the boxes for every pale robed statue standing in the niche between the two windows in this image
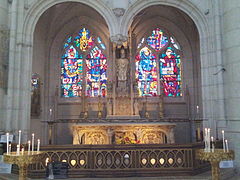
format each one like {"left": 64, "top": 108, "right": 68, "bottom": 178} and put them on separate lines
{"left": 117, "top": 48, "right": 129, "bottom": 81}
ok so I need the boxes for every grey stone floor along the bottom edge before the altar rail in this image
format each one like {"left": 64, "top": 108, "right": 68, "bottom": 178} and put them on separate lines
{"left": 0, "top": 169, "right": 240, "bottom": 180}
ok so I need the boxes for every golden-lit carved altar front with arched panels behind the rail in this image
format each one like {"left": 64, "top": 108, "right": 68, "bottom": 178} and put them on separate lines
{"left": 72, "top": 123, "right": 175, "bottom": 145}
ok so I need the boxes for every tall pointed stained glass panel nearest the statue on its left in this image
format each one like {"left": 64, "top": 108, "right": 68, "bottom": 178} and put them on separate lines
{"left": 86, "top": 46, "right": 107, "bottom": 97}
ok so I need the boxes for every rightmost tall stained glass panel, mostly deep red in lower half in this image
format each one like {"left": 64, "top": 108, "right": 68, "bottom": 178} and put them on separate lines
{"left": 160, "top": 47, "right": 182, "bottom": 97}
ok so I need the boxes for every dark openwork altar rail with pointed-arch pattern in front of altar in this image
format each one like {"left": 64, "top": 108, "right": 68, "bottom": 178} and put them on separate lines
{"left": 24, "top": 143, "right": 210, "bottom": 178}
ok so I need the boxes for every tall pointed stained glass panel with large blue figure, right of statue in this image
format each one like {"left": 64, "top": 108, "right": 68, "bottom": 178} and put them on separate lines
{"left": 135, "top": 47, "right": 157, "bottom": 96}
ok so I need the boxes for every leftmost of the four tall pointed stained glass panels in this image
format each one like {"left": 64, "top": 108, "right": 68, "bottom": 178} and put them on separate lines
{"left": 61, "top": 46, "right": 83, "bottom": 97}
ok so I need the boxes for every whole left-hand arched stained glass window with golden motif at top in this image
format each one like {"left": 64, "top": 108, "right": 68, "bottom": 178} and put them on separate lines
{"left": 61, "top": 28, "right": 107, "bottom": 97}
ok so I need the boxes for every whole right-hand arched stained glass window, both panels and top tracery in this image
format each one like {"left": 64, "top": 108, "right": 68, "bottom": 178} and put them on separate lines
{"left": 135, "top": 28, "right": 182, "bottom": 97}
